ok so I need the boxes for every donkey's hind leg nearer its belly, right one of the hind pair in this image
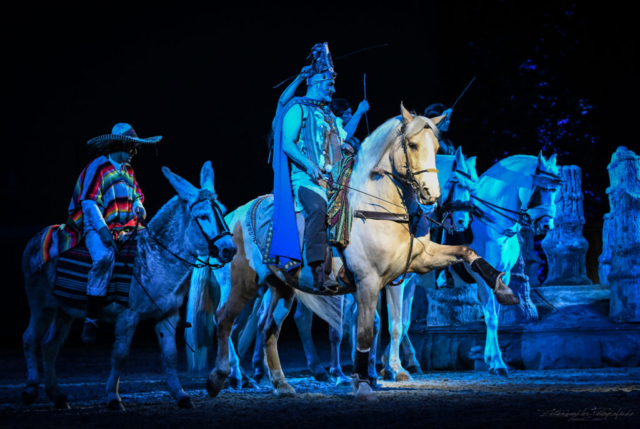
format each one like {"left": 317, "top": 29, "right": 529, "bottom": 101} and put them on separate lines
{"left": 42, "top": 309, "right": 74, "bottom": 409}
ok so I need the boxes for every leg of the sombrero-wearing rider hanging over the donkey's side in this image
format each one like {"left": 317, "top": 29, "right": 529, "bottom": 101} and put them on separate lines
{"left": 82, "top": 228, "right": 115, "bottom": 344}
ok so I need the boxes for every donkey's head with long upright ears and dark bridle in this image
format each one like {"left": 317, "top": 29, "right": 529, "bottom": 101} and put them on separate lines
{"left": 162, "top": 161, "right": 238, "bottom": 264}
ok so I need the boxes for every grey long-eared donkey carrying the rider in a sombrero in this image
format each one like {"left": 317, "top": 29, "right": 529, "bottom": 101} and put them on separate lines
{"left": 22, "top": 162, "right": 237, "bottom": 410}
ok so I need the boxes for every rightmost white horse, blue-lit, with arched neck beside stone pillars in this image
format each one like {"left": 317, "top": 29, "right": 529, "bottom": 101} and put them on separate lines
{"left": 465, "top": 152, "right": 562, "bottom": 376}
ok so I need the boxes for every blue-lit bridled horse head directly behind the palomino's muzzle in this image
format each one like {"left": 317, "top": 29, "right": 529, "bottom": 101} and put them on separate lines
{"left": 441, "top": 148, "right": 479, "bottom": 231}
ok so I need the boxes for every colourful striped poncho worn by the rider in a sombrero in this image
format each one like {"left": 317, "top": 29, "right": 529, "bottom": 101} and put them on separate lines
{"left": 42, "top": 156, "right": 144, "bottom": 264}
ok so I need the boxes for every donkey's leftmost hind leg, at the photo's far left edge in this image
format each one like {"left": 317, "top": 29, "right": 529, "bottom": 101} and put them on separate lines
{"left": 22, "top": 308, "right": 55, "bottom": 405}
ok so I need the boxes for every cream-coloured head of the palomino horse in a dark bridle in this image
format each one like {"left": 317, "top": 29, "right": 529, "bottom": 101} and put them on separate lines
{"left": 391, "top": 103, "right": 440, "bottom": 205}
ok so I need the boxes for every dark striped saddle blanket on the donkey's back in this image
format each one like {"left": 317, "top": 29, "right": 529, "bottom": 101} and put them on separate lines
{"left": 52, "top": 240, "right": 137, "bottom": 305}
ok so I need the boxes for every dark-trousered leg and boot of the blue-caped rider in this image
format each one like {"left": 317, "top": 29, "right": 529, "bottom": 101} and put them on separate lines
{"left": 298, "top": 187, "right": 339, "bottom": 291}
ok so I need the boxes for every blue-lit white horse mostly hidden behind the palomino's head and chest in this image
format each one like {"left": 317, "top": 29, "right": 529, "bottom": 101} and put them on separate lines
{"left": 383, "top": 148, "right": 478, "bottom": 381}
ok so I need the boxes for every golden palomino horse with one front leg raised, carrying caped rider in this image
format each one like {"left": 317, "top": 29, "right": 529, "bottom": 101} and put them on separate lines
{"left": 206, "top": 107, "right": 517, "bottom": 400}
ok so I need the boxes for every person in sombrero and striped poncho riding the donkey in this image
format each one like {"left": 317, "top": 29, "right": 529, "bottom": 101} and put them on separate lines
{"left": 70, "top": 123, "right": 162, "bottom": 344}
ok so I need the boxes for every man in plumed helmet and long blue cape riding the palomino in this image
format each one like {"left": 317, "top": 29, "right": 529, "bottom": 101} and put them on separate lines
{"left": 269, "top": 43, "right": 347, "bottom": 291}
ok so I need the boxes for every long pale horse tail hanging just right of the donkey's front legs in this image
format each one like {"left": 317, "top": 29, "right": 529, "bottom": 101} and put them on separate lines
{"left": 185, "top": 267, "right": 220, "bottom": 372}
